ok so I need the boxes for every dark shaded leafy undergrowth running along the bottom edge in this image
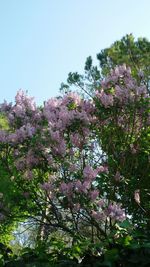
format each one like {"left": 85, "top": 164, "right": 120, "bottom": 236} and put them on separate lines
{"left": 0, "top": 242, "right": 150, "bottom": 267}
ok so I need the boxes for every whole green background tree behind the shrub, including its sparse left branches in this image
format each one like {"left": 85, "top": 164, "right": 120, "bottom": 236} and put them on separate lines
{"left": 61, "top": 34, "right": 150, "bottom": 95}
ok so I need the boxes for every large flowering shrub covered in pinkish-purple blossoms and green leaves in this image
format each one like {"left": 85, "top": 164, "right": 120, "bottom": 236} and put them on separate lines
{"left": 0, "top": 65, "right": 150, "bottom": 245}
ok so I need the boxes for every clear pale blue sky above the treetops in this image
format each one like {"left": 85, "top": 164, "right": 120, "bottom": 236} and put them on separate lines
{"left": 0, "top": 0, "right": 150, "bottom": 104}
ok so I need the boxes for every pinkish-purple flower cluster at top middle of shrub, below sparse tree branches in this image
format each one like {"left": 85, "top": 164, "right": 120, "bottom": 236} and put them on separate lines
{"left": 43, "top": 94, "right": 93, "bottom": 131}
